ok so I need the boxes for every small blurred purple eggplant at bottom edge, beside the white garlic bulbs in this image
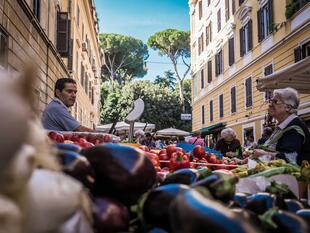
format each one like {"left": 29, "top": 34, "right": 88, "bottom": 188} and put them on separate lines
{"left": 93, "top": 198, "right": 129, "bottom": 233}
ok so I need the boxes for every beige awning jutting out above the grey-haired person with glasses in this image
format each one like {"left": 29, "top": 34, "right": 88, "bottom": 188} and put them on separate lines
{"left": 257, "top": 57, "right": 310, "bottom": 94}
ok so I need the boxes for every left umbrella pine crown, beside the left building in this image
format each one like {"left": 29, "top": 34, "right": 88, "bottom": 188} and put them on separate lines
{"left": 99, "top": 33, "right": 148, "bottom": 85}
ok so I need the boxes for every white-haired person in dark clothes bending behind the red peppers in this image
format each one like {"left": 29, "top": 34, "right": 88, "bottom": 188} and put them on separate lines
{"left": 215, "top": 128, "right": 242, "bottom": 157}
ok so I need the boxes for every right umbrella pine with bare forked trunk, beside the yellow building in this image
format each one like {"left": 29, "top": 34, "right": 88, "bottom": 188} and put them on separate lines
{"left": 147, "top": 29, "right": 190, "bottom": 112}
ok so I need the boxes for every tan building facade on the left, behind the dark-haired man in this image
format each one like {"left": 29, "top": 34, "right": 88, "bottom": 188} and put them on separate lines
{"left": 0, "top": 0, "right": 102, "bottom": 127}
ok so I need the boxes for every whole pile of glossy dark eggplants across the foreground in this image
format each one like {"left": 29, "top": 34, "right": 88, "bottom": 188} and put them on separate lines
{"left": 60, "top": 144, "right": 310, "bottom": 233}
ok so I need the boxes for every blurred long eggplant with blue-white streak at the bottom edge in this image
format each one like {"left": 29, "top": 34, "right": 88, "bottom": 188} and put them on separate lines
{"left": 169, "top": 189, "right": 261, "bottom": 233}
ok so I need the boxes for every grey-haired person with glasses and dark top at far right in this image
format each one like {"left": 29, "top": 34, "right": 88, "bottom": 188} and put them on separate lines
{"left": 253, "top": 88, "right": 310, "bottom": 164}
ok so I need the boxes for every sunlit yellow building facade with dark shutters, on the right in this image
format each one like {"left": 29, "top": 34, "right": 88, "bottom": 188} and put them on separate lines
{"left": 189, "top": 0, "right": 310, "bottom": 144}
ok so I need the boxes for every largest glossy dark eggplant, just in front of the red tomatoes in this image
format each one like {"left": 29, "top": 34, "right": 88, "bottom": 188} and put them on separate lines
{"left": 81, "top": 143, "right": 156, "bottom": 205}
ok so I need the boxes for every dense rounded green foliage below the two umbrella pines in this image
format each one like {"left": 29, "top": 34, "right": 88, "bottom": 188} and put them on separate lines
{"left": 101, "top": 80, "right": 191, "bottom": 131}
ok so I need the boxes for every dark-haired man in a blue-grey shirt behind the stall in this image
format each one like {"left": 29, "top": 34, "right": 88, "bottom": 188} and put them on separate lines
{"left": 42, "top": 78, "right": 93, "bottom": 132}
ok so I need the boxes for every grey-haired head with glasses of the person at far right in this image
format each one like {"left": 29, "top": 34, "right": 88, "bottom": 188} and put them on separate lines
{"left": 268, "top": 87, "right": 299, "bottom": 120}
